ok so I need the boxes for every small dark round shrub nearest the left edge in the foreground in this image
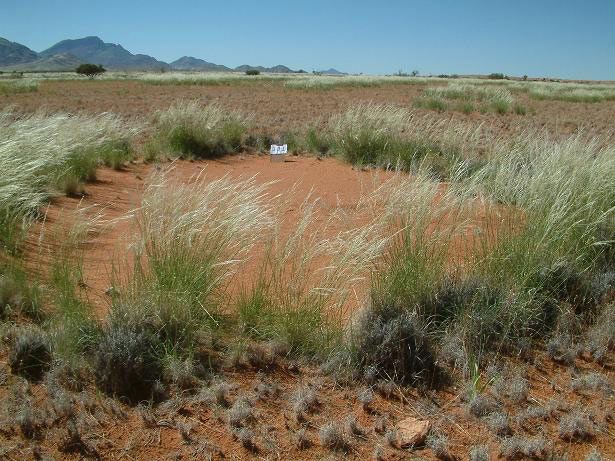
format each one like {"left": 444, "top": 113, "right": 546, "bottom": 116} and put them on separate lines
{"left": 9, "top": 327, "right": 52, "bottom": 381}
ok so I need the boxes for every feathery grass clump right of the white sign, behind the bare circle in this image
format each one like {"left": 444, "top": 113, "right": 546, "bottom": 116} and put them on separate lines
{"left": 326, "top": 104, "right": 479, "bottom": 177}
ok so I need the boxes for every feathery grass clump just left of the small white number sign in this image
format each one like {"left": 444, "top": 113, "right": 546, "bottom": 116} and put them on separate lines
{"left": 148, "top": 101, "right": 248, "bottom": 158}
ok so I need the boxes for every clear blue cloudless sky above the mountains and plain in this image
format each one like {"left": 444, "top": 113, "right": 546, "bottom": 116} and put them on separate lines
{"left": 0, "top": 0, "right": 615, "bottom": 80}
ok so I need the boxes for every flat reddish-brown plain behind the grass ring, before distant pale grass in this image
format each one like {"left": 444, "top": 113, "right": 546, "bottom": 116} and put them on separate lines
{"left": 0, "top": 81, "right": 615, "bottom": 136}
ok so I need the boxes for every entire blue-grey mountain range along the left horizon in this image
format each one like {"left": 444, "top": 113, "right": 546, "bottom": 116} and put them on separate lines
{"left": 0, "top": 36, "right": 341, "bottom": 74}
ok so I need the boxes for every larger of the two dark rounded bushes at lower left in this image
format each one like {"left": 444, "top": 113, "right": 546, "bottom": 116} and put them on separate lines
{"left": 95, "top": 325, "right": 162, "bottom": 404}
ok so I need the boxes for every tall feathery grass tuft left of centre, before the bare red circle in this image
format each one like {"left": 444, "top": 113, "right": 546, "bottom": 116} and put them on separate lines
{"left": 111, "top": 169, "right": 272, "bottom": 351}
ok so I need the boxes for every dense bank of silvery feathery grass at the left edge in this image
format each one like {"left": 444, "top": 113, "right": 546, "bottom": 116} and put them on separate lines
{"left": 0, "top": 110, "right": 139, "bottom": 250}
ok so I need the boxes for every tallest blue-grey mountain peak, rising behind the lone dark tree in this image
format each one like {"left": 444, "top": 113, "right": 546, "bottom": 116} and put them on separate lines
{"left": 39, "top": 37, "right": 169, "bottom": 70}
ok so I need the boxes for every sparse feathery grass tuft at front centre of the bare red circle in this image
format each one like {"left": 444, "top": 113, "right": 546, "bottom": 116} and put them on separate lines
{"left": 239, "top": 191, "right": 388, "bottom": 358}
